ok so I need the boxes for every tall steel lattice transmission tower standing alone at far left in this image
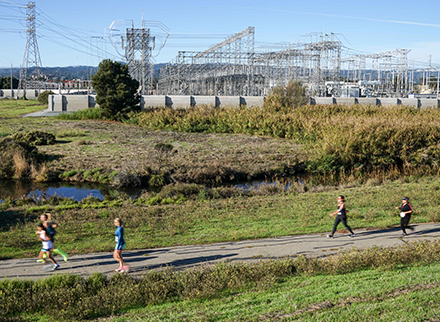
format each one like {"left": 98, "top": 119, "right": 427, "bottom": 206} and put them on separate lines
{"left": 18, "top": 2, "right": 42, "bottom": 89}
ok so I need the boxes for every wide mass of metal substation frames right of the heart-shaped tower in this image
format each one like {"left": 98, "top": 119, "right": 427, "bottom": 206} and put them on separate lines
{"left": 157, "top": 27, "right": 412, "bottom": 97}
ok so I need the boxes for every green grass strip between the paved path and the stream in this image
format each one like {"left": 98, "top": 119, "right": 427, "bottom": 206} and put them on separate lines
{"left": 0, "top": 177, "right": 440, "bottom": 258}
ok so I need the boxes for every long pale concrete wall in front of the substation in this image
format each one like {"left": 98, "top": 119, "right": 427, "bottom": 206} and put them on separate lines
{"left": 47, "top": 94, "right": 439, "bottom": 111}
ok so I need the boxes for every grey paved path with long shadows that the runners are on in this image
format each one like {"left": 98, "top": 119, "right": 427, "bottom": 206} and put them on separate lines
{"left": 0, "top": 223, "right": 440, "bottom": 279}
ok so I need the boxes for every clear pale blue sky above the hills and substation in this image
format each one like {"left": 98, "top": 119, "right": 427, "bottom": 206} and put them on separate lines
{"left": 0, "top": 0, "right": 440, "bottom": 69}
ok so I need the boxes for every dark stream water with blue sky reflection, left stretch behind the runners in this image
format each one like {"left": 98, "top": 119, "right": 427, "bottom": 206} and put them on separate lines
{"left": 0, "top": 180, "right": 142, "bottom": 202}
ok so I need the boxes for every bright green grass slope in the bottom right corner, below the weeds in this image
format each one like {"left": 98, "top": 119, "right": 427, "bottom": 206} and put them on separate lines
{"left": 115, "top": 263, "right": 440, "bottom": 322}
